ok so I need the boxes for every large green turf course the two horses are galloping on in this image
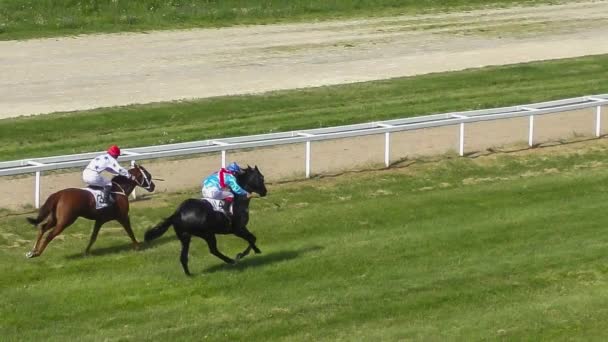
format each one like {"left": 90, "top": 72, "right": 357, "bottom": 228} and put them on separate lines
{"left": 0, "top": 140, "right": 608, "bottom": 341}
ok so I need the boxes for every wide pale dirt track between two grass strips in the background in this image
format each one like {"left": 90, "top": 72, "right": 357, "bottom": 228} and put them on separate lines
{"left": 0, "top": 1, "right": 608, "bottom": 118}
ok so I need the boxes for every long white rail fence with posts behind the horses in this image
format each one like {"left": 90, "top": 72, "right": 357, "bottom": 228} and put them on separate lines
{"left": 0, "top": 94, "right": 608, "bottom": 208}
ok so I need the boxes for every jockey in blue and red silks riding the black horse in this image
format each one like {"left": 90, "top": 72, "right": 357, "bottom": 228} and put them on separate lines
{"left": 202, "top": 162, "right": 251, "bottom": 215}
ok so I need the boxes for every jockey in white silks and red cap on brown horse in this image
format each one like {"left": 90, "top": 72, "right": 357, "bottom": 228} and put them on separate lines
{"left": 82, "top": 145, "right": 135, "bottom": 204}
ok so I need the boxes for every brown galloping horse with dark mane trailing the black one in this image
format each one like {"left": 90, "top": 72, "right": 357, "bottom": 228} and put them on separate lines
{"left": 25, "top": 165, "right": 155, "bottom": 258}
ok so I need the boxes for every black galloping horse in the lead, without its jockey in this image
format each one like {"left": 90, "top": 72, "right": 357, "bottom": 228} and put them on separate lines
{"left": 144, "top": 166, "right": 267, "bottom": 275}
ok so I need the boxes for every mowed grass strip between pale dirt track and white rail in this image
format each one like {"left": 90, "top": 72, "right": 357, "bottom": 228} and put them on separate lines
{"left": 0, "top": 55, "right": 608, "bottom": 160}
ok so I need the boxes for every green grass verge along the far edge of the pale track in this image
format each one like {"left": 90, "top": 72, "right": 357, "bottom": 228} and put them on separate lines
{"left": 0, "top": 0, "right": 555, "bottom": 40}
